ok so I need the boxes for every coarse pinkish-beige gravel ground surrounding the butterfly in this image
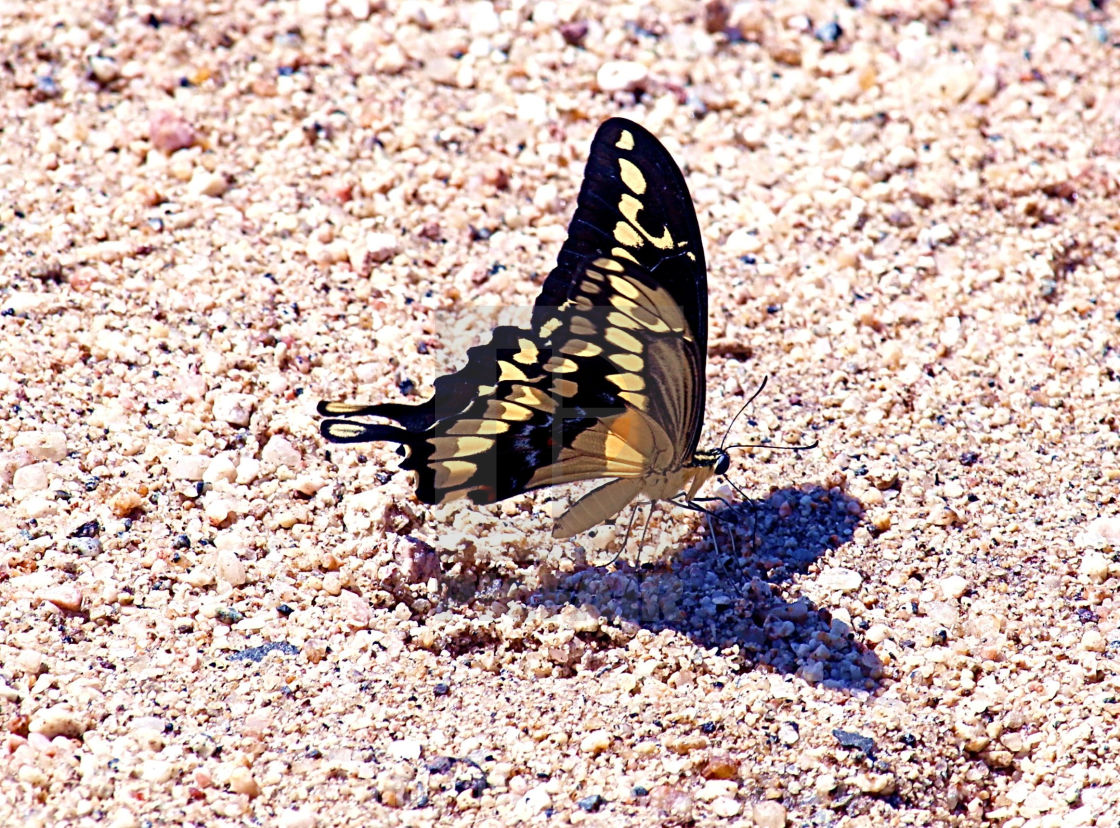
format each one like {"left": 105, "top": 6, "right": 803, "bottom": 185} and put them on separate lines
{"left": 0, "top": 0, "right": 1120, "bottom": 828}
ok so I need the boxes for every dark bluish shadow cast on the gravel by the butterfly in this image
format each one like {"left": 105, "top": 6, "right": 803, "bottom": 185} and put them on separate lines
{"left": 441, "top": 486, "right": 883, "bottom": 690}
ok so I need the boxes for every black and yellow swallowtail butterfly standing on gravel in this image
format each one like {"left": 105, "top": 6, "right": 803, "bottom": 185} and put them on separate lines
{"left": 318, "top": 118, "right": 730, "bottom": 538}
